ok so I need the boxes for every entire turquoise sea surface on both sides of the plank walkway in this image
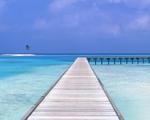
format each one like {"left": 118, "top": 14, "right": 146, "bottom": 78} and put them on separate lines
{"left": 0, "top": 55, "right": 150, "bottom": 120}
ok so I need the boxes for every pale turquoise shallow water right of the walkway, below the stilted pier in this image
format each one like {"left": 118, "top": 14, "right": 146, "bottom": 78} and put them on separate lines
{"left": 93, "top": 65, "right": 150, "bottom": 120}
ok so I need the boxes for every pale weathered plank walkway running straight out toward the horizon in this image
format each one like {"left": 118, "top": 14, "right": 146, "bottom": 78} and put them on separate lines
{"left": 23, "top": 58, "right": 123, "bottom": 120}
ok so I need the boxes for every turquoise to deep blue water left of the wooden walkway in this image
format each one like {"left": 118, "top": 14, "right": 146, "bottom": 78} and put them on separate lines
{"left": 0, "top": 56, "right": 75, "bottom": 120}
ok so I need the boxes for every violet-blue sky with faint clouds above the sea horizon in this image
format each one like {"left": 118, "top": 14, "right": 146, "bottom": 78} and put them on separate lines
{"left": 0, "top": 0, "right": 150, "bottom": 54}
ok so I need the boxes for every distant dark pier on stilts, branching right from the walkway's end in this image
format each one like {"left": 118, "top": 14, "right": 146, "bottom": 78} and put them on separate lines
{"left": 87, "top": 56, "right": 150, "bottom": 65}
